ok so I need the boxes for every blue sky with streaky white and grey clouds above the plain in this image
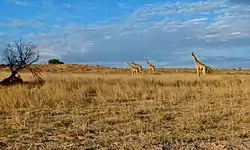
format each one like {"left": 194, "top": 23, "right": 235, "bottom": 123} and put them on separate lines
{"left": 0, "top": 0, "right": 250, "bottom": 68}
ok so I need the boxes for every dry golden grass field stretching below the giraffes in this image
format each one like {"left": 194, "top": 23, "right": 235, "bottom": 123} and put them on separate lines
{"left": 0, "top": 65, "right": 250, "bottom": 150}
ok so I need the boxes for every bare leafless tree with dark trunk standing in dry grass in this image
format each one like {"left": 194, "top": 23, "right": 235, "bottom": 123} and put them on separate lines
{"left": 0, "top": 40, "right": 39, "bottom": 85}
